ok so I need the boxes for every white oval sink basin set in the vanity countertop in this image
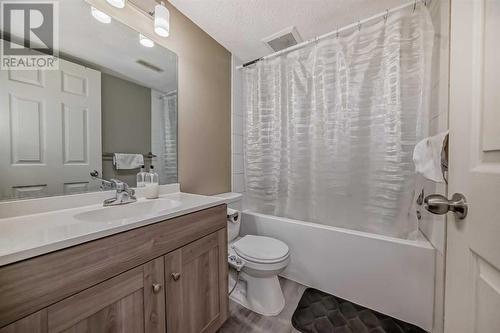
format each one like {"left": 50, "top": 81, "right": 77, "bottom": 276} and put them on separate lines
{"left": 74, "top": 199, "right": 181, "bottom": 222}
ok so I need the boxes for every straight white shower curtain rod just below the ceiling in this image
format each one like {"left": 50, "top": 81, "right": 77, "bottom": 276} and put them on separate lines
{"left": 236, "top": 0, "right": 432, "bottom": 69}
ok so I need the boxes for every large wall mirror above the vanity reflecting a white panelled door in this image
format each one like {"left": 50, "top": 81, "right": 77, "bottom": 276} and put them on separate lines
{"left": 0, "top": 0, "right": 177, "bottom": 200}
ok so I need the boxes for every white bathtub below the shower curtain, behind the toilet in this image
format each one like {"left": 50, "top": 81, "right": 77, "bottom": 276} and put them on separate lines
{"left": 240, "top": 211, "right": 435, "bottom": 331}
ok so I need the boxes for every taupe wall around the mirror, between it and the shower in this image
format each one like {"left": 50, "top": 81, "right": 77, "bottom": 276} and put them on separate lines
{"left": 87, "top": 0, "right": 231, "bottom": 194}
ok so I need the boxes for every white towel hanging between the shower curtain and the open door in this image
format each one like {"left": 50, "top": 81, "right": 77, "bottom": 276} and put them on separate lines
{"left": 413, "top": 131, "right": 448, "bottom": 183}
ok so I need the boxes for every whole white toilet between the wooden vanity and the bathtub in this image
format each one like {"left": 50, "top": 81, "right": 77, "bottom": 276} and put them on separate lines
{"left": 214, "top": 193, "right": 290, "bottom": 316}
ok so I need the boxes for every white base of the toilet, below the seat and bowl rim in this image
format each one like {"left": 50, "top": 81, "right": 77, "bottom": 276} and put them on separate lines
{"left": 230, "top": 271, "right": 285, "bottom": 316}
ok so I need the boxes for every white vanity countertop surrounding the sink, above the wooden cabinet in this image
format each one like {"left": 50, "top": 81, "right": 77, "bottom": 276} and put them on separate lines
{"left": 0, "top": 192, "right": 226, "bottom": 266}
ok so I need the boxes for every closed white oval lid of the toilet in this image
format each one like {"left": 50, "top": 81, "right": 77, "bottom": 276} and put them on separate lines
{"left": 232, "top": 235, "right": 289, "bottom": 262}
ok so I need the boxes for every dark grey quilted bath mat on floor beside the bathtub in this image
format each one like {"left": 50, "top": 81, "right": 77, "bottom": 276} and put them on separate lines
{"left": 292, "top": 288, "right": 425, "bottom": 333}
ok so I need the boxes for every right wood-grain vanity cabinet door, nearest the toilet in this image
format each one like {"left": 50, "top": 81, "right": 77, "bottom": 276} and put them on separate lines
{"left": 165, "top": 229, "right": 228, "bottom": 333}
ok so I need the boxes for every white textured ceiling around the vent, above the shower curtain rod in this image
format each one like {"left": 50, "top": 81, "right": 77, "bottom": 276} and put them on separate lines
{"left": 169, "top": 0, "right": 410, "bottom": 62}
